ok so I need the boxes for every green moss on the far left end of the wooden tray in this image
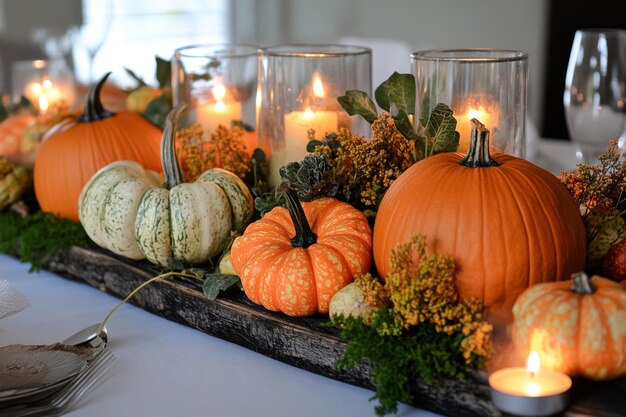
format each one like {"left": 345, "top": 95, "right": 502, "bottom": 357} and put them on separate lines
{"left": 0, "top": 211, "right": 91, "bottom": 272}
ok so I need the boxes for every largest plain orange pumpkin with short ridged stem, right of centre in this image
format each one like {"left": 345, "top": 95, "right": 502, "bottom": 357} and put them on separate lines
{"left": 374, "top": 119, "right": 586, "bottom": 321}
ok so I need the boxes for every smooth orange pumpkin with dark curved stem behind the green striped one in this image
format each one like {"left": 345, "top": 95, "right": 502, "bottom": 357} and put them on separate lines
{"left": 35, "top": 73, "right": 161, "bottom": 221}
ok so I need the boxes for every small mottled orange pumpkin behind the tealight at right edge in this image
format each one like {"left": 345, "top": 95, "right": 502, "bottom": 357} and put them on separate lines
{"left": 513, "top": 272, "right": 626, "bottom": 379}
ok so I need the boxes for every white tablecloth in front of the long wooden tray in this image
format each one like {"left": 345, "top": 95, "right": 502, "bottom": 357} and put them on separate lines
{"left": 0, "top": 141, "right": 575, "bottom": 417}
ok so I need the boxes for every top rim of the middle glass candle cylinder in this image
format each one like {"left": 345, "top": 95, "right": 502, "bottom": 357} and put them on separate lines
{"left": 261, "top": 43, "right": 372, "bottom": 58}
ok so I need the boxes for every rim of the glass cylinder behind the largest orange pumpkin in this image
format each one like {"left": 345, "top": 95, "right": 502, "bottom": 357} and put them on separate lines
{"left": 411, "top": 48, "right": 528, "bottom": 63}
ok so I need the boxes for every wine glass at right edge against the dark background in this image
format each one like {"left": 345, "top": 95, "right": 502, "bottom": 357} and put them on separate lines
{"left": 563, "top": 29, "right": 626, "bottom": 163}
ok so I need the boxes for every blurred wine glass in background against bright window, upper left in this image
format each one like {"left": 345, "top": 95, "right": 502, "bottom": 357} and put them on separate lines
{"left": 73, "top": 0, "right": 113, "bottom": 83}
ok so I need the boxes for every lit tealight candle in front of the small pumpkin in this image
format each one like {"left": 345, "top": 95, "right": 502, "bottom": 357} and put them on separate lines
{"left": 489, "top": 351, "right": 572, "bottom": 416}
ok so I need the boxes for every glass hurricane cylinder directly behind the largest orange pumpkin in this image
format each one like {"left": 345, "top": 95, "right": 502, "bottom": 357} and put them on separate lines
{"left": 411, "top": 49, "right": 528, "bottom": 157}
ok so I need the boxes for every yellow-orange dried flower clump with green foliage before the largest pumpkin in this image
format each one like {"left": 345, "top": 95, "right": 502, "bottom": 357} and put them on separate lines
{"left": 332, "top": 235, "right": 493, "bottom": 415}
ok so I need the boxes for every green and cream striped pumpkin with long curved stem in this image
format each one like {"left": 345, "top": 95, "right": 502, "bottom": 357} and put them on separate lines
{"left": 78, "top": 105, "right": 254, "bottom": 266}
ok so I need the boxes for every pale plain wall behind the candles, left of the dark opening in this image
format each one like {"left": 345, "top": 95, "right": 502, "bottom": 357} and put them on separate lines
{"left": 232, "top": 0, "right": 548, "bottom": 132}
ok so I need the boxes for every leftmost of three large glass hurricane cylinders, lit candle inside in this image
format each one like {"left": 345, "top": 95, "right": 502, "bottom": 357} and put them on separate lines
{"left": 172, "top": 44, "right": 259, "bottom": 147}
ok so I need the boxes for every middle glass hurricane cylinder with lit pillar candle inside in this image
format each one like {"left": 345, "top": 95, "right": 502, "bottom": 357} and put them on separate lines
{"left": 259, "top": 45, "right": 372, "bottom": 186}
